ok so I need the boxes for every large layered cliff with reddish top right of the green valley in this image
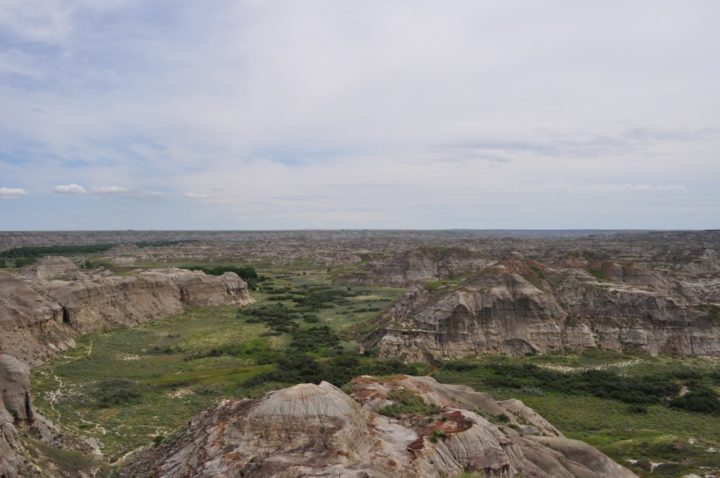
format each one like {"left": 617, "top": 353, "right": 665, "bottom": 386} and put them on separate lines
{"left": 367, "top": 261, "right": 720, "bottom": 361}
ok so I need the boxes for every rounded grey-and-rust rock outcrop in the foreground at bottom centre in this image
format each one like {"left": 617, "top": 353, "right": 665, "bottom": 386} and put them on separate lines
{"left": 121, "top": 376, "right": 635, "bottom": 478}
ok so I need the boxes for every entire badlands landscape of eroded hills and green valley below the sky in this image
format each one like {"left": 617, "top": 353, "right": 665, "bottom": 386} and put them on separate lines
{"left": 0, "top": 231, "right": 720, "bottom": 478}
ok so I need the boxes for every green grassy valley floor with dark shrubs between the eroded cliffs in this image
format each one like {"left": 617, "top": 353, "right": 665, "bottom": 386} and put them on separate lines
{"left": 33, "top": 267, "right": 720, "bottom": 477}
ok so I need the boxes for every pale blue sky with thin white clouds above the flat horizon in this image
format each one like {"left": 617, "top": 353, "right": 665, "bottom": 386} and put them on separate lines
{"left": 0, "top": 0, "right": 720, "bottom": 230}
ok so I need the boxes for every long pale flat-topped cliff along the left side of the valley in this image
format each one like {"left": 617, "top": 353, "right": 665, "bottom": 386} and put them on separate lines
{"left": 0, "top": 269, "right": 252, "bottom": 365}
